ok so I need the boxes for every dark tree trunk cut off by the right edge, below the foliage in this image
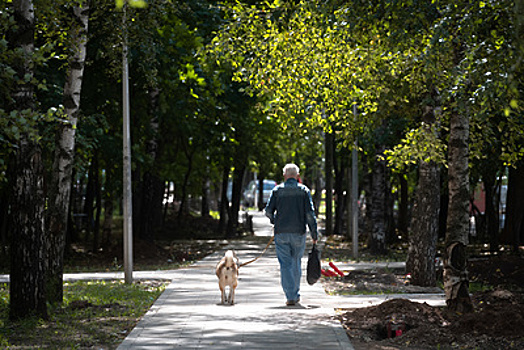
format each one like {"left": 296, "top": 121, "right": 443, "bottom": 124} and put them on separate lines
{"left": 505, "top": 161, "right": 524, "bottom": 253}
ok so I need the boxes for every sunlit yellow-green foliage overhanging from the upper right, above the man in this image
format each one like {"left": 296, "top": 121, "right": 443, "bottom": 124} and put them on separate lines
{"left": 209, "top": 1, "right": 524, "bottom": 170}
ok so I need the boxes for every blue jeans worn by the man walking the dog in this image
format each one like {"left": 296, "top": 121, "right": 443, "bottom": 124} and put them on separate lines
{"left": 275, "top": 233, "right": 306, "bottom": 301}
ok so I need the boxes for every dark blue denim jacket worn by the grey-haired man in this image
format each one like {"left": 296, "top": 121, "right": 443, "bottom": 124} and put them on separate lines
{"left": 266, "top": 178, "right": 318, "bottom": 240}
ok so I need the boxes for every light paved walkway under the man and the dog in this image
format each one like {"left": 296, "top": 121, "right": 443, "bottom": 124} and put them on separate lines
{"left": 118, "top": 209, "right": 353, "bottom": 350}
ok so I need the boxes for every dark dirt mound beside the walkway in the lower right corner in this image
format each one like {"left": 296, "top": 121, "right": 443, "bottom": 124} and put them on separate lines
{"left": 339, "top": 290, "right": 524, "bottom": 350}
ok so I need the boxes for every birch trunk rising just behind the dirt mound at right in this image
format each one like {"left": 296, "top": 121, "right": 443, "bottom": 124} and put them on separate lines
{"left": 444, "top": 111, "right": 473, "bottom": 313}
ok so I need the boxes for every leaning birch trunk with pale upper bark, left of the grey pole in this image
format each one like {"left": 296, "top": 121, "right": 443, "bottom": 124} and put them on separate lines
{"left": 46, "top": 0, "right": 89, "bottom": 303}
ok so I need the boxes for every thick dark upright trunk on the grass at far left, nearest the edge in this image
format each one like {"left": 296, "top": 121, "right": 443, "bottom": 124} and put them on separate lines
{"left": 8, "top": 0, "right": 47, "bottom": 320}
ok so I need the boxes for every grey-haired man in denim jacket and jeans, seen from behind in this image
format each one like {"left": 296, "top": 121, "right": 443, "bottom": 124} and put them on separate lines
{"left": 266, "top": 164, "right": 318, "bottom": 306}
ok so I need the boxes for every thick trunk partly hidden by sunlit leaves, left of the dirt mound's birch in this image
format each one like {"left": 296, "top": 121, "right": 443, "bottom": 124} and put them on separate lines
{"left": 406, "top": 106, "right": 440, "bottom": 287}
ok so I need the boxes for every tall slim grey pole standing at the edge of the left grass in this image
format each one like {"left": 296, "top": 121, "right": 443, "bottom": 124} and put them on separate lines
{"left": 122, "top": 3, "right": 133, "bottom": 284}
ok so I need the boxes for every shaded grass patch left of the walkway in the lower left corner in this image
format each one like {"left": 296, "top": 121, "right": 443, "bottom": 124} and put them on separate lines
{"left": 0, "top": 281, "right": 166, "bottom": 349}
